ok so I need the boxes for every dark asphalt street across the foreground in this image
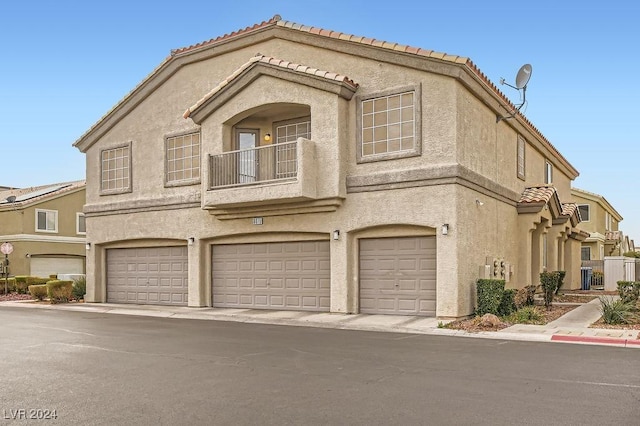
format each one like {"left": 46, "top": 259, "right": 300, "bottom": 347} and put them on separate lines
{"left": 0, "top": 307, "right": 640, "bottom": 425}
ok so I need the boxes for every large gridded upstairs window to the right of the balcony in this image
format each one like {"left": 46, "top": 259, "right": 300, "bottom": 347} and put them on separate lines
{"left": 362, "top": 92, "right": 415, "bottom": 156}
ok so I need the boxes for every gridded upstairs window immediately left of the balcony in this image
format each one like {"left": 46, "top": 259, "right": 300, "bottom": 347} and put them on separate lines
{"left": 165, "top": 132, "right": 200, "bottom": 185}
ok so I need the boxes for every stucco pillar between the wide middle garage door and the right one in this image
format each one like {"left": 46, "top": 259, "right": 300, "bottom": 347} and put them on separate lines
{"left": 329, "top": 232, "right": 350, "bottom": 313}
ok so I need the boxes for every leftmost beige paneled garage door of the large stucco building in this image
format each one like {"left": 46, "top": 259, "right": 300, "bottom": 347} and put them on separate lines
{"left": 107, "top": 247, "right": 188, "bottom": 305}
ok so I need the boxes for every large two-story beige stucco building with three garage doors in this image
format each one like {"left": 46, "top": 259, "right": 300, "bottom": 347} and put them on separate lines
{"left": 74, "top": 16, "right": 586, "bottom": 317}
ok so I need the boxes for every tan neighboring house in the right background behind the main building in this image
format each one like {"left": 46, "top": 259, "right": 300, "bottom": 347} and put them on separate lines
{"left": 571, "top": 188, "right": 630, "bottom": 260}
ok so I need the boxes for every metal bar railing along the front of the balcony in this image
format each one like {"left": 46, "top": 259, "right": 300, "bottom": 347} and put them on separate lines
{"left": 210, "top": 142, "right": 298, "bottom": 189}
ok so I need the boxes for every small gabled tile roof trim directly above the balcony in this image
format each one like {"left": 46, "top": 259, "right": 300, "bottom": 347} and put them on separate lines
{"left": 183, "top": 53, "right": 358, "bottom": 118}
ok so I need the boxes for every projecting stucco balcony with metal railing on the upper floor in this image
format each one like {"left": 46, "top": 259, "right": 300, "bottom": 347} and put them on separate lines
{"left": 203, "top": 138, "right": 317, "bottom": 214}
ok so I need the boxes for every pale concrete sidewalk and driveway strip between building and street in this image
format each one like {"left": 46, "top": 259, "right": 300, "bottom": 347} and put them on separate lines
{"left": 0, "top": 299, "right": 640, "bottom": 348}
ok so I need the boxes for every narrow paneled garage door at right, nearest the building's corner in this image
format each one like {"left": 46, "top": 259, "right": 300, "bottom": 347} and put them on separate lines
{"left": 360, "top": 237, "right": 436, "bottom": 316}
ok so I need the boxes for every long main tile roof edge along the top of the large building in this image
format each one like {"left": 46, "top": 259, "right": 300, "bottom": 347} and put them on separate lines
{"left": 74, "top": 15, "right": 578, "bottom": 175}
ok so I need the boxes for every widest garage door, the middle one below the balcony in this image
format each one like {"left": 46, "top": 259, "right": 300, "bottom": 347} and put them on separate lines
{"left": 212, "top": 241, "right": 330, "bottom": 311}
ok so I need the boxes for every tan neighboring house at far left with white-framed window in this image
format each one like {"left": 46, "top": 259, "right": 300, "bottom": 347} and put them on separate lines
{"left": 0, "top": 181, "right": 86, "bottom": 278}
